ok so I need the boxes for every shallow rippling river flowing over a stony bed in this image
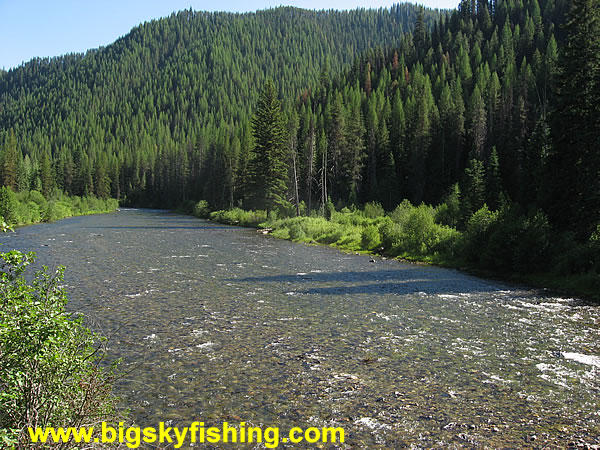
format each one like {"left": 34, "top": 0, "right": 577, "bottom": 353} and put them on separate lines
{"left": 0, "top": 210, "right": 600, "bottom": 448}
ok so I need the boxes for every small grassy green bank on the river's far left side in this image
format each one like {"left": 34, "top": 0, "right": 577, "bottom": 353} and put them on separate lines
{"left": 0, "top": 187, "right": 119, "bottom": 226}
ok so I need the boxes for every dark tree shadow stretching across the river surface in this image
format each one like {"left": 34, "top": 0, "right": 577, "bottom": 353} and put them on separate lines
{"left": 228, "top": 267, "right": 501, "bottom": 295}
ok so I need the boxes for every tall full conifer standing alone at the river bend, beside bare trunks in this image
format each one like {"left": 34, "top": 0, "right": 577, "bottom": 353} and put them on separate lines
{"left": 249, "top": 80, "right": 288, "bottom": 211}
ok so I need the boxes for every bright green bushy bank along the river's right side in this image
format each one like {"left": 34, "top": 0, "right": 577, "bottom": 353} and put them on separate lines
{"left": 188, "top": 201, "right": 600, "bottom": 300}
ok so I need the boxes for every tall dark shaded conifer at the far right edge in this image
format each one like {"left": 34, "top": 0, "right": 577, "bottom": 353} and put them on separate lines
{"left": 545, "top": 0, "right": 600, "bottom": 238}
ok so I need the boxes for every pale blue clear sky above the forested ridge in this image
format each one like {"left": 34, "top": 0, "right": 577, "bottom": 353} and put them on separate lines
{"left": 0, "top": 0, "right": 458, "bottom": 70}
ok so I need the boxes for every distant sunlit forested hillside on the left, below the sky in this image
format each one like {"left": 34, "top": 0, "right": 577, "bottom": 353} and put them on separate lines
{"left": 0, "top": 4, "right": 439, "bottom": 207}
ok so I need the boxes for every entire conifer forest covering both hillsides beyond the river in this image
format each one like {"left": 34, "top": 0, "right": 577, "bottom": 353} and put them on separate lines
{"left": 0, "top": 0, "right": 600, "bottom": 289}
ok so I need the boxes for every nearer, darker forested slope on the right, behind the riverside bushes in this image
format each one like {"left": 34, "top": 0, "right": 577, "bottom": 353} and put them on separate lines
{"left": 286, "top": 0, "right": 565, "bottom": 213}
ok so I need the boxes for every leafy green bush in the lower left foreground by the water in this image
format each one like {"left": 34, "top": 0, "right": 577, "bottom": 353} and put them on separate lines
{"left": 0, "top": 251, "right": 116, "bottom": 448}
